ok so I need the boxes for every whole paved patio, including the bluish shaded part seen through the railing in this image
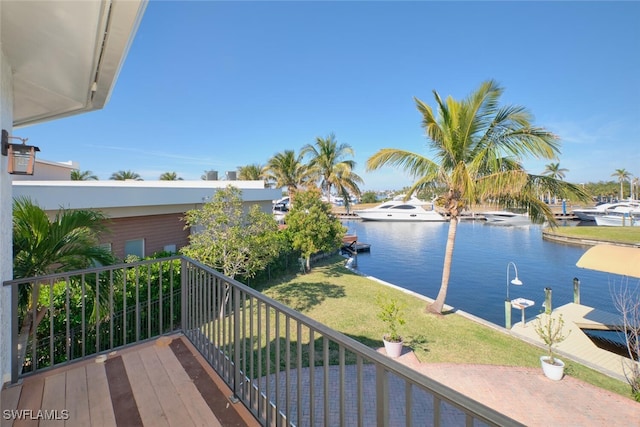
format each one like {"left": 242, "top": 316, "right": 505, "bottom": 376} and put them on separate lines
{"left": 261, "top": 349, "right": 640, "bottom": 427}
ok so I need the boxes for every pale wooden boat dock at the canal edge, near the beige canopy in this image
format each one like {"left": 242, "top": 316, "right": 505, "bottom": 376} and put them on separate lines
{"left": 511, "top": 303, "right": 628, "bottom": 381}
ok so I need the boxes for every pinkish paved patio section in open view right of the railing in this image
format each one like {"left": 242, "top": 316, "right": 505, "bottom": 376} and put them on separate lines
{"left": 390, "top": 350, "right": 640, "bottom": 426}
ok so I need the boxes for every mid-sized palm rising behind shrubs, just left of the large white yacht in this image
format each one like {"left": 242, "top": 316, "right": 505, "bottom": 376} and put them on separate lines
{"left": 301, "top": 134, "right": 363, "bottom": 205}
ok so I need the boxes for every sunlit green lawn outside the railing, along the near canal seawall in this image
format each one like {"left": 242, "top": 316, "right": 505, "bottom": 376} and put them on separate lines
{"left": 259, "top": 256, "right": 631, "bottom": 398}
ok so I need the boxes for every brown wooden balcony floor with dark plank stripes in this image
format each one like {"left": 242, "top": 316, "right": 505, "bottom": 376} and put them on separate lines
{"left": 1, "top": 336, "right": 258, "bottom": 427}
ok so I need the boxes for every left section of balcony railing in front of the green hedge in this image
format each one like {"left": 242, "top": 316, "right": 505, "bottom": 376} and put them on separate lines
{"left": 4, "top": 256, "right": 182, "bottom": 382}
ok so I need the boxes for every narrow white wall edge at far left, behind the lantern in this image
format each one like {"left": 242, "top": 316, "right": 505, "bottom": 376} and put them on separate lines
{"left": 0, "top": 46, "right": 13, "bottom": 383}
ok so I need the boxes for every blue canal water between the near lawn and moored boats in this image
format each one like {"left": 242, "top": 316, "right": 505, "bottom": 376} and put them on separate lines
{"left": 343, "top": 221, "right": 637, "bottom": 326}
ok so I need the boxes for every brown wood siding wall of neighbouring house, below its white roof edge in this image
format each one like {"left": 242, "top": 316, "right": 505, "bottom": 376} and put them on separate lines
{"left": 100, "top": 213, "right": 189, "bottom": 259}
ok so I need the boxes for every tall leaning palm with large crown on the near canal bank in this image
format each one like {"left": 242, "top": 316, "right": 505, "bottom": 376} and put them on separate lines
{"left": 367, "top": 80, "right": 587, "bottom": 313}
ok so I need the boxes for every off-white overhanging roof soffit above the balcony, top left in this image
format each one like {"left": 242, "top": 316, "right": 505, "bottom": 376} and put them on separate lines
{"left": 0, "top": 0, "right": 147, "bottom": 127}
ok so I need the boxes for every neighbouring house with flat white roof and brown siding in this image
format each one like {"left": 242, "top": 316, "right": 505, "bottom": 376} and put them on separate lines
{"left": 13, "top": 178, "right": 282, "bottom": 259}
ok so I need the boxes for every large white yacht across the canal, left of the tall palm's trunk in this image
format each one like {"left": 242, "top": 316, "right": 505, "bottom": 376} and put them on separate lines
{"left": 353, "top": 196, "right": 447, "bottom": 221}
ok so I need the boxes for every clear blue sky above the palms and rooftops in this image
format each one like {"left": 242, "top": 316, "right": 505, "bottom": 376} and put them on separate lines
{"left": 17, "top": 0, "right": 640, "bottom": 190}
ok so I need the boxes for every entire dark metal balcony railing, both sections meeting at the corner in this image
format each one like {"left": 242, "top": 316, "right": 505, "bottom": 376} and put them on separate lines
{"left": 4, "top": 256, "right": 520, "bottom": 426}
